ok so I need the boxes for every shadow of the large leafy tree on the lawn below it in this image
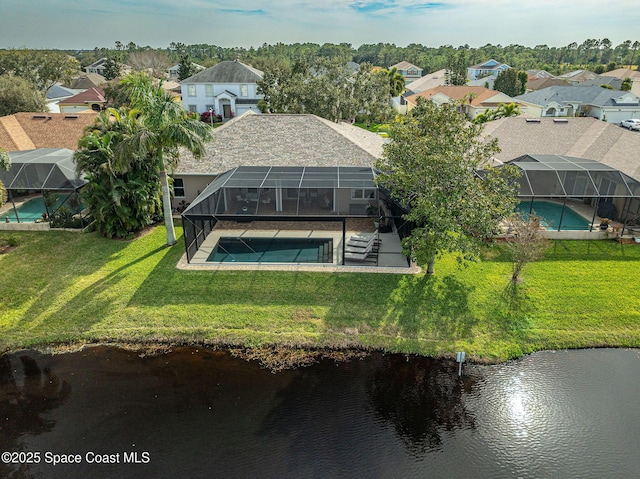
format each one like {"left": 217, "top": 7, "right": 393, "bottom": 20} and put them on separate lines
{"left": 325, "top": 275, "right": 478, "bottom": 341}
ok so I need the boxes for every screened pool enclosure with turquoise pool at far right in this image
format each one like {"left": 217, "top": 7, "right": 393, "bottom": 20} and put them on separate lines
{"left": 492, "top": 155, "right": 640, "bottom": 231}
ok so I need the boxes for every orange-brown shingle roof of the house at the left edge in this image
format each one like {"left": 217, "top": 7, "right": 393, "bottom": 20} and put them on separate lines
{"left": 0, "top": 111, "right": 97, "bottom": 151}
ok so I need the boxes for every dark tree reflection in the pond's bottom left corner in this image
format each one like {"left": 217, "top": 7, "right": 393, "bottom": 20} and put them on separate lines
{"left": 0, "top": 354, "right": 71, "bottom": 479}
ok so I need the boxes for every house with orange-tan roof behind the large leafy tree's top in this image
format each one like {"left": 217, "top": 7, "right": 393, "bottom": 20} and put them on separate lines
{"left": 406, "top": 86, "right": 526, "bottom": 120}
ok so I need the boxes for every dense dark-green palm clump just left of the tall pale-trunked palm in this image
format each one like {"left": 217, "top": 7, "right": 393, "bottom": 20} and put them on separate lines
{"left": 74, "top": 108, "right": 162, "bottom": 238}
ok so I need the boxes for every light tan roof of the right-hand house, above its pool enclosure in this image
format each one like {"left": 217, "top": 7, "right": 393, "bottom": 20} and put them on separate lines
{"left": 484, "top": 117, "right": 640, "bottom": 181}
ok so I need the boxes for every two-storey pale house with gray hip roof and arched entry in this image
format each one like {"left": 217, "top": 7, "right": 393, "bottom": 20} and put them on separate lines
{"left": 181, "top": 60, "right": 263, "bottom": 119}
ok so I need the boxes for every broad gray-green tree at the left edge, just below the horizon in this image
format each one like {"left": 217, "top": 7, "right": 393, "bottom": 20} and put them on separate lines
{"left": 0, "top": 49, "right": 80, "bottom": 91}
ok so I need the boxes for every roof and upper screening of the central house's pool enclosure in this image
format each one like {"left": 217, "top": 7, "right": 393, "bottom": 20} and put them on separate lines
{"left": 182, "top": 166, "right": 402, "bottom": 260}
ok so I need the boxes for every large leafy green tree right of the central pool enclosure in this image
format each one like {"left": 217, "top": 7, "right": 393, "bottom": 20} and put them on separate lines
{"left": 376, "top": 99, "right": 518, "bottom": 274}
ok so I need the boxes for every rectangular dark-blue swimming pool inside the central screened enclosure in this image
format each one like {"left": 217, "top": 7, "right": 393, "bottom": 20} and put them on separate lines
{"left": 207, "top": 237, "right": 333, "bottom": 263}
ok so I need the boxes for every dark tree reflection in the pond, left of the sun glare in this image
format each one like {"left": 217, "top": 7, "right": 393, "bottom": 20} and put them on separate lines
{"left": 368, "top": 355, "right": 476, "bottom": 456}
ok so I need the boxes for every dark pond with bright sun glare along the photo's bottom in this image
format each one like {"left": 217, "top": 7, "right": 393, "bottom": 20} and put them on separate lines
{"left": 0, "top": 347, "right": 640, "bottom": 478}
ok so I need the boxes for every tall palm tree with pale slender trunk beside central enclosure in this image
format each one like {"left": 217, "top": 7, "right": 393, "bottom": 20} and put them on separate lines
{"left": 115, "top": 73, "right": 212, "bottom": 246}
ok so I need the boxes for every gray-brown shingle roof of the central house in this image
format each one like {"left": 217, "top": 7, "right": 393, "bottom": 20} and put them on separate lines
{"left": 176, "top": 112, "right": 384, "bottom": 174}
